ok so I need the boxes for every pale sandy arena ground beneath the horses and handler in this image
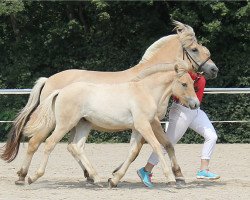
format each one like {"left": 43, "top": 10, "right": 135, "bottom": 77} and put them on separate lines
{"left": 0, "top": 144, "right": 250, "bottom": 200}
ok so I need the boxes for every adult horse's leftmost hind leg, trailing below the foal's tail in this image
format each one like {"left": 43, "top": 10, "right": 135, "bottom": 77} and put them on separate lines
{"left": 15, "top": 129, "right": 50, "bottom": 185}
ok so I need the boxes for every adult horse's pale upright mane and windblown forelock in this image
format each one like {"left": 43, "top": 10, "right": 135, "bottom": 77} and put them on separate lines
{"left": 139, "top": 21, "right": 197, "bottom": 63}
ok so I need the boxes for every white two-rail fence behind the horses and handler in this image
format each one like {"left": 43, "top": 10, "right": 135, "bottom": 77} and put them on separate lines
{"left": 0, "top": 88, "right": 250, "bottom": 123}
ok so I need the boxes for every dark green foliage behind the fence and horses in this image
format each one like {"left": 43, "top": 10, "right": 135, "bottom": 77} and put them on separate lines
{"left": 0, "top": 0, "right": 250, "bottom": 143}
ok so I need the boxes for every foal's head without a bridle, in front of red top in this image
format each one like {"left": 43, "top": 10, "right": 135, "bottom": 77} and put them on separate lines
{"left": 172, "top": 61, "right": 200, "bottom": 109}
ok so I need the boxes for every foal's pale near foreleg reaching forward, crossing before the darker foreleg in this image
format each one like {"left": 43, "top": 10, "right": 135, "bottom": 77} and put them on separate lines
{"left": 134, "top": 116, "right": 176, "bottom": 183}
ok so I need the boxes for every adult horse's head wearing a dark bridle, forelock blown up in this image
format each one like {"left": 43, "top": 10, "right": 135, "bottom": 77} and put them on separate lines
{"left": 174, "top": 21, "right": 219, "bottom": 79}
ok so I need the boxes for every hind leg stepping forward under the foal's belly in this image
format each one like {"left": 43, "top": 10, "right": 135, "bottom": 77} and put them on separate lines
{"left": 68, "top": 121, "right": 101, "bottom": 183}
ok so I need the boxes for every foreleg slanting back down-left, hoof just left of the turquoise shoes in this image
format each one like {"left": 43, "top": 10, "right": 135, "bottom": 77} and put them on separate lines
{"left": 109, "top": 131, "right": 144, "bottom": 187}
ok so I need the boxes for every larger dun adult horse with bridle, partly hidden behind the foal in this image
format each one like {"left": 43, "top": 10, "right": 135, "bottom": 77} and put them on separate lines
{"left": 1, "top": 21, "right": 218, "bottom": 184}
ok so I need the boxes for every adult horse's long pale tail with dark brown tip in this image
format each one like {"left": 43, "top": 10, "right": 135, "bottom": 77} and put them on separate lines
{"left": 0, "top": 78, "right": 47, "bottom": 162}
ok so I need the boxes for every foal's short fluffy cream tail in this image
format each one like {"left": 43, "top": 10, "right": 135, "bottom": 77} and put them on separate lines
{"left": 23, "top": 90, "right": 59, "bottom": 137}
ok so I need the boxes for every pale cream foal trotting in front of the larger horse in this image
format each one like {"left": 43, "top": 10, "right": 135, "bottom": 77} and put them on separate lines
{"left": 23, "top": 61, "right": 199, "bottom": 186}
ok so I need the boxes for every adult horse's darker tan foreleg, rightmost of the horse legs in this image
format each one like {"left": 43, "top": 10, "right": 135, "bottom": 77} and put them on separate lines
{"left": 151, "top": 118, "right": 185, "bottom": 182}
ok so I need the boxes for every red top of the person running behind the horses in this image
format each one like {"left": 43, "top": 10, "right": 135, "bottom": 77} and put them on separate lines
{"left": 173, "top": 72, "right": 206, "bottom": 103}
